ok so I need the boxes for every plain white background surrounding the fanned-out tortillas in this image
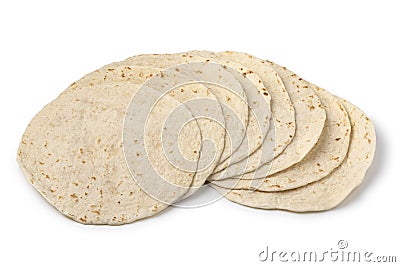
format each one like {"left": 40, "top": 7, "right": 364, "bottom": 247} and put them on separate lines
{"left": 0, "top": 0, "right": 400, "bottom": 266}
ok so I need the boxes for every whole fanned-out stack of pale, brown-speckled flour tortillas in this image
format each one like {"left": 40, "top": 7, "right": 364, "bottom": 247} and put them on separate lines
{"left": 17, "top": 51, "right": 376, "bottom": 225}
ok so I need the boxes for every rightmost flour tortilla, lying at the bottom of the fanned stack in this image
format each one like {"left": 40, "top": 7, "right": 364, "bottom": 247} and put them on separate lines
{"left": 212, "top": 99, "right": 376, "bottom": 212}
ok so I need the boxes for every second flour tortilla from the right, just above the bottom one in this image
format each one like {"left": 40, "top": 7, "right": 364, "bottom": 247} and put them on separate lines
{"left": 212, "top": 84, "right": 351, "bottom": 192}
